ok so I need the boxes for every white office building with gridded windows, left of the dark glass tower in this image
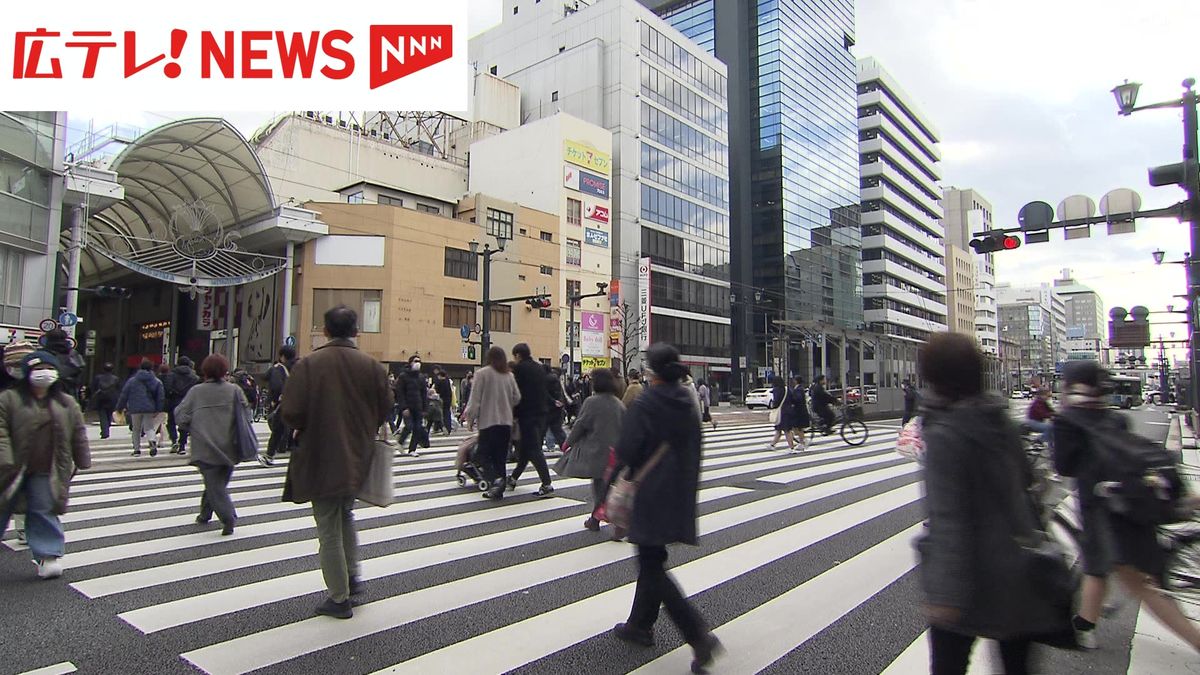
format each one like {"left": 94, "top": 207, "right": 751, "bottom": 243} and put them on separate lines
{"left": 469, "top": 0, "right": 731, "bottom": 389}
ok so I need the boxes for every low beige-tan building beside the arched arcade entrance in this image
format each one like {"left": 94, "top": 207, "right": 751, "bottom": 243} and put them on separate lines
{"left": 293, "top": 196, "right": 559, "bottom": 376}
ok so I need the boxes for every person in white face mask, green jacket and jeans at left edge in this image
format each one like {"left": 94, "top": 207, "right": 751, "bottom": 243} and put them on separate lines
{"left": 0, "top": 352, "right": 91, "bottom": 579}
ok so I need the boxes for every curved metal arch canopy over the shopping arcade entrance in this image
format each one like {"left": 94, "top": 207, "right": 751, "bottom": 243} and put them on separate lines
{"left": 80, "top": 118, "right": 287, "bottom": 284}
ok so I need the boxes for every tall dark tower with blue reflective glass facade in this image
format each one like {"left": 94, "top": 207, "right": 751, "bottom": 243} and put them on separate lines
{"left": 642, "top": 0, "right": 863, "bottom": 380}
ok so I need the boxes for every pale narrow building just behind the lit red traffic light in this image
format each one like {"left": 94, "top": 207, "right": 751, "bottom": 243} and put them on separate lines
{"left": 942, "top": 187, "right": 1000, "bottom": 356}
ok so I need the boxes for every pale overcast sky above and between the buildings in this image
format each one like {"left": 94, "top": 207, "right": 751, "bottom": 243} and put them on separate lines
{"left": 72, "top": 0, "right": 1200, "bottom": 355}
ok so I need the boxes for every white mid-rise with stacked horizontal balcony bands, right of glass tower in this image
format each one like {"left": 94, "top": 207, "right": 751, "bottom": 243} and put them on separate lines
{"left": 858, "top": 58, "right": 948, "bottom": 341}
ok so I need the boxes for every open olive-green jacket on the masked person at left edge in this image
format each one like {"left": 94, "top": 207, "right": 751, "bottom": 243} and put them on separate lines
{"left": 0, "top": 389, "right": 91, "bottom": 514}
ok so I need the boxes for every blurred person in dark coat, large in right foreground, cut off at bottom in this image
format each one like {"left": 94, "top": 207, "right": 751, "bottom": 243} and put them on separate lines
{"left": 917, "top": 333, "right": 1068, "bottom": 675}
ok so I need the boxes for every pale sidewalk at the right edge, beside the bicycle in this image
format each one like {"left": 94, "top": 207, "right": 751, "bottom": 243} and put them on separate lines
{"left": 1128, "top": 414, "right": 1200, "bottom": 675}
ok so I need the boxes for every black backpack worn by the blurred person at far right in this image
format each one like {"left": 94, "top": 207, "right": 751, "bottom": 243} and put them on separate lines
{"left": 1082, "top": 417, "right": 1188, "bottom": 525}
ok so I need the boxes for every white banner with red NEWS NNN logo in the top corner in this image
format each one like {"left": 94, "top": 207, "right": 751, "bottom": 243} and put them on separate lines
{"left": 0, "top": 0, "right": 470, "bottom": 110}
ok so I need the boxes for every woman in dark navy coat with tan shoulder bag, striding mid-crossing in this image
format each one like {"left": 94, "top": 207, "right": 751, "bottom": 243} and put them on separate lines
{"left": 613, "top": 344, "right": 721, "bottom": 673}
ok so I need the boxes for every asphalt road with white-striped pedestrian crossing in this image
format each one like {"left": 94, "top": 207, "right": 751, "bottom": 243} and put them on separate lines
{"left": 0, "top": 401, "right": 1166, "bottom": 675}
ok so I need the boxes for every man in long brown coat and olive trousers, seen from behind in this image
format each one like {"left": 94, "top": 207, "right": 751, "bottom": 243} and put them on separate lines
{"left": 280, "top": 305, "right": 392, "bottom": 619}
